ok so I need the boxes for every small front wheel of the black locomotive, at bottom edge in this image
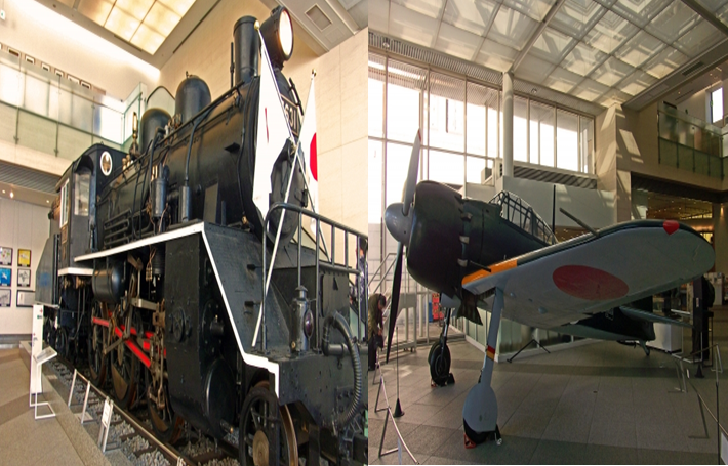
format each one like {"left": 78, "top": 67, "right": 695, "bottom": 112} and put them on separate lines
{"left": 239, "top": 381, "right": 298, "bottom": 466}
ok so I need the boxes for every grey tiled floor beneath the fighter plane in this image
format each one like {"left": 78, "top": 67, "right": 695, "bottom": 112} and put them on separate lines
{"left": 368, "top": 311, "right": 728, "bottom": 464}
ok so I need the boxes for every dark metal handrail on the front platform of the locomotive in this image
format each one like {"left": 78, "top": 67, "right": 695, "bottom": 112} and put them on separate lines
{"left": 253, "top": 202, "right": 367, "bottom": 353}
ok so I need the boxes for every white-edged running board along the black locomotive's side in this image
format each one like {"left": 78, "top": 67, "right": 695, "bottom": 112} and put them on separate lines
{"left": 75, "top": 221, "right": 285, "bottom": 396}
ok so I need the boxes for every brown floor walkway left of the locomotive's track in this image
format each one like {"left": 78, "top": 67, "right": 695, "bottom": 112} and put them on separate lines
{"left": 0, "top": 349, "right": 109, "bottom": 465}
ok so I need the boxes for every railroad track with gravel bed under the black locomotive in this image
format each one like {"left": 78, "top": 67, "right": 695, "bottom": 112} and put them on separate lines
{"left": 48, "top": 359, "right": 239, "bottom": 466}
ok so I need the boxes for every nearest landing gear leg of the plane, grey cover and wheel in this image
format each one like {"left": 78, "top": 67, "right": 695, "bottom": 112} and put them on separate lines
{"left": 463, "top": 288, "right": 503, "bottom": 448}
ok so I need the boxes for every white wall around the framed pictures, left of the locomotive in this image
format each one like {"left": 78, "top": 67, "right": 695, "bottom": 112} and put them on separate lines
{"left": 0, "top": 198, "right": 49, "bottom": 335}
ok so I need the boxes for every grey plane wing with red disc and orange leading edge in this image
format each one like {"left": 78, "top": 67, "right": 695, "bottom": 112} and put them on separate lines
{"left": 462, "top": 220, "right": 715, "bottom": 329}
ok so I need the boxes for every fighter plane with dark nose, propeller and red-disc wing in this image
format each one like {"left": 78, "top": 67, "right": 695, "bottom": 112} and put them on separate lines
{"left": 385, "top": 131, "right": 715, "bottom": 448}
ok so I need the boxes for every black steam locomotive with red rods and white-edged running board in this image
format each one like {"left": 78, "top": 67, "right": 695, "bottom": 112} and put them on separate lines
{"left": 36, "top": 7, "right": 367, "bottom": 466}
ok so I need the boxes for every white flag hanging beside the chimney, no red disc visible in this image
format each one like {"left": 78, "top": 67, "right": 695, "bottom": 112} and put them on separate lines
{"left": 253, "top": 33, "right": 292, "bottom": 218}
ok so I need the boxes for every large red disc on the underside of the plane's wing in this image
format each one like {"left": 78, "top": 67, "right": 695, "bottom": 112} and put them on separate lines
{"left": 553, "top": 265, "right": 629, "bottom": 301}
